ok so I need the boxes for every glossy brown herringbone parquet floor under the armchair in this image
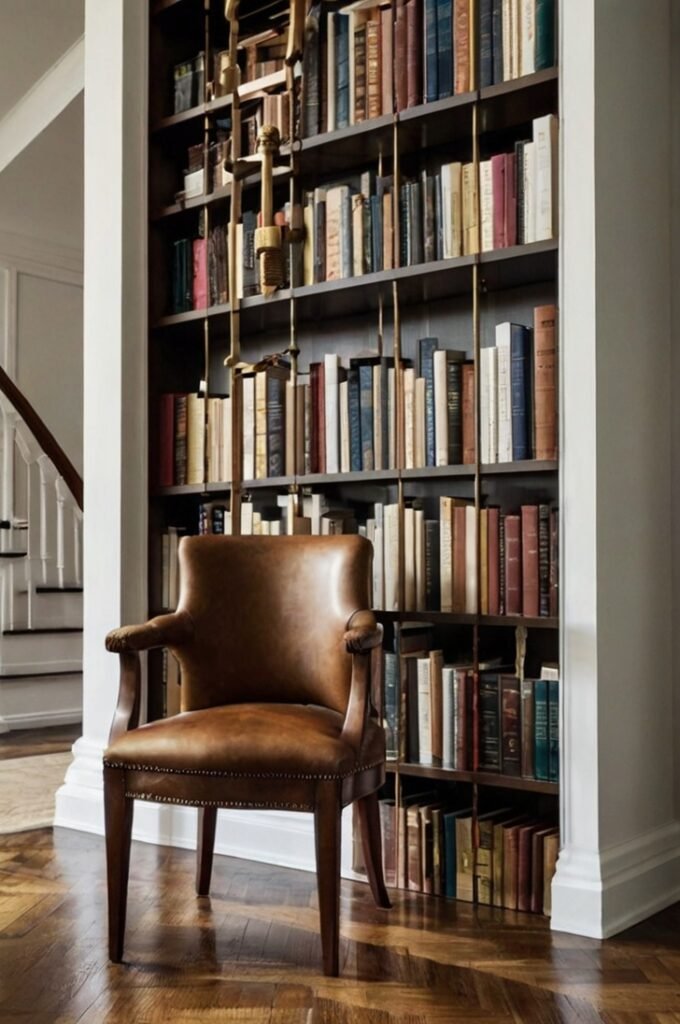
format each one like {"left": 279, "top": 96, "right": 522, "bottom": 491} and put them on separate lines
{"left": 0, "top": 829, "right": 680, "bottom": 1024}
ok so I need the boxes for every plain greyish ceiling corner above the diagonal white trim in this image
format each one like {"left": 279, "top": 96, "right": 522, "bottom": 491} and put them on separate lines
{"left": 0, "top": 0, "right": 85, "bottom": 118}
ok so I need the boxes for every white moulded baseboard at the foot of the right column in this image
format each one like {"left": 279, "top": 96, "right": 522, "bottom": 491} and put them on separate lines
{"left": 551, "top": 821, "right": 680, "bottom": 939}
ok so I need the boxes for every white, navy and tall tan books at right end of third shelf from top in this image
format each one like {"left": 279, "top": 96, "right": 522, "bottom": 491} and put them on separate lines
{"left": 479, "top": 305, "right": 557, "bottom": 465}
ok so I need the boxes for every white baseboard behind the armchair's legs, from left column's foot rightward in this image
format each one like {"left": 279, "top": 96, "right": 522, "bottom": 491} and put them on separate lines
{"left": 54, "top": 739, "right": 356, "bottom": 878}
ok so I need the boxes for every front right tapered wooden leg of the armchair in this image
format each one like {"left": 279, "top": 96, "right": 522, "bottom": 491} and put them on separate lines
{"left": 314, "top": 782, "right": 342, "bottom": 978}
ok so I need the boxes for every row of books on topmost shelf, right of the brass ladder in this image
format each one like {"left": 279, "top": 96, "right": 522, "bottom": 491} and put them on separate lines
{"left": 302, "top": 0, "right": 555, "bottom": 136}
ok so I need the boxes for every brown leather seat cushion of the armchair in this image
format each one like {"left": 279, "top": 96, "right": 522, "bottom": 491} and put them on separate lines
{"left": 104, "top": 703, "right": 385, "bottom": 778}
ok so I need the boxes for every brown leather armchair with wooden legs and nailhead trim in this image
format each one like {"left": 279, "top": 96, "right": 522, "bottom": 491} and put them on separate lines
{"left": 103, "top": 537, "right": 389, "bottom": 975}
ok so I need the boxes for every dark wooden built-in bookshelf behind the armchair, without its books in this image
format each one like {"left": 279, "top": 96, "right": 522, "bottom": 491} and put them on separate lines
{"left": 148, "top": 0, "right": 560, "bottom": 913}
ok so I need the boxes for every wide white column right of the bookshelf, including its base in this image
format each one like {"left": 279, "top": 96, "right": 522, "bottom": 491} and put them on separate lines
{"left": 552, "top": 0, "right": 680, "bottom": 937}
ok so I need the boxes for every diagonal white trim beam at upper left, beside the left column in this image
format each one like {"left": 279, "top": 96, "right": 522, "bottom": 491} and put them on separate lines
{"left": 0, "top": 36, "right": 85, "bottom": 172}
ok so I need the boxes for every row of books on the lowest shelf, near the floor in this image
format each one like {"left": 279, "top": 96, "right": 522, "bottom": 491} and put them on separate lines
{"left": 366, "top": 793, "right": 559, "bottom": 915}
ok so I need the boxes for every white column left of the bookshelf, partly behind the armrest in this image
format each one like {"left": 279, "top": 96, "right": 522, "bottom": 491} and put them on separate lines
{"left": 56, "top": 0, "right": 147, "bottom": 830}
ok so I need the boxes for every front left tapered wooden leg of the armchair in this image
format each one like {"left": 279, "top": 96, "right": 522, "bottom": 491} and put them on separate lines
{"left": 103, "top": 768, "right": 134, "bottom": 964}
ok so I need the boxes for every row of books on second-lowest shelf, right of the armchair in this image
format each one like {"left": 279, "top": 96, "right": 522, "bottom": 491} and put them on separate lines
{"left": 383, "top": 650, "right": 559, "bottom": 782}
